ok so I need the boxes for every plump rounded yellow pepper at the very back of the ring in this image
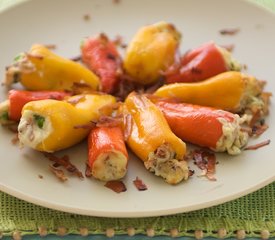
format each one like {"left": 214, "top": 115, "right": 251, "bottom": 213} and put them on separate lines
{"left": 124, "top": 22, "right": 181, "bottom": 85}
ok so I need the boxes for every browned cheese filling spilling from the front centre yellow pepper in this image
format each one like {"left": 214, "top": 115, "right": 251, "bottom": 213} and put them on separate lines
{"left": 144, "top": 143, "right": 189, "bottom": 184}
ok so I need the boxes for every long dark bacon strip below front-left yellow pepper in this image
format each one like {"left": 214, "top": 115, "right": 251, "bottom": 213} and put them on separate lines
{"left": 44, "top": 153, "right": 84, "bottom": 179}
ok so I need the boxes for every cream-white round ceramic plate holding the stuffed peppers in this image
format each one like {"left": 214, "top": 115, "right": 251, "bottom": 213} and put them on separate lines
{"left": 0, "top": 0, "right": 275, "bottom": 217}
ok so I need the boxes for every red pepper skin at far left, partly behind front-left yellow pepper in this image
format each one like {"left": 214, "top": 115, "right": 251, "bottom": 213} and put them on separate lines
{"left": 8, "top": 89, "right": 70, "bottom": 122}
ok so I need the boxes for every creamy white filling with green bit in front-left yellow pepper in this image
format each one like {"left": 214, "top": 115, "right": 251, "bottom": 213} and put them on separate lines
{"left": 18, "top": 110, "right": 53, "bottom": 149}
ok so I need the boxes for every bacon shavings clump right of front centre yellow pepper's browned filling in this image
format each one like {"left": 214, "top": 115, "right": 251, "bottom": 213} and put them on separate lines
{"left": 193, "top": 150, "right": 217, "bottom": 181}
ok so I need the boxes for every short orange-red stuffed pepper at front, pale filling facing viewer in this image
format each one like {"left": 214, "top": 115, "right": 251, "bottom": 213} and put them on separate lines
{"left": 88, "top": 126, "right": 128, "bottom": 181}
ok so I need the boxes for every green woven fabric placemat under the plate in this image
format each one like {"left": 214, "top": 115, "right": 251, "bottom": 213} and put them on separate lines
{"left": 0, "top": 0, "right": 275, "bottom": 238}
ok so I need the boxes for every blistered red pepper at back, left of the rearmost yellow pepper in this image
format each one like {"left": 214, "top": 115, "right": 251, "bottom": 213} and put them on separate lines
{"left": 81, "top": 33, "right": 122, "bottom": 93}
